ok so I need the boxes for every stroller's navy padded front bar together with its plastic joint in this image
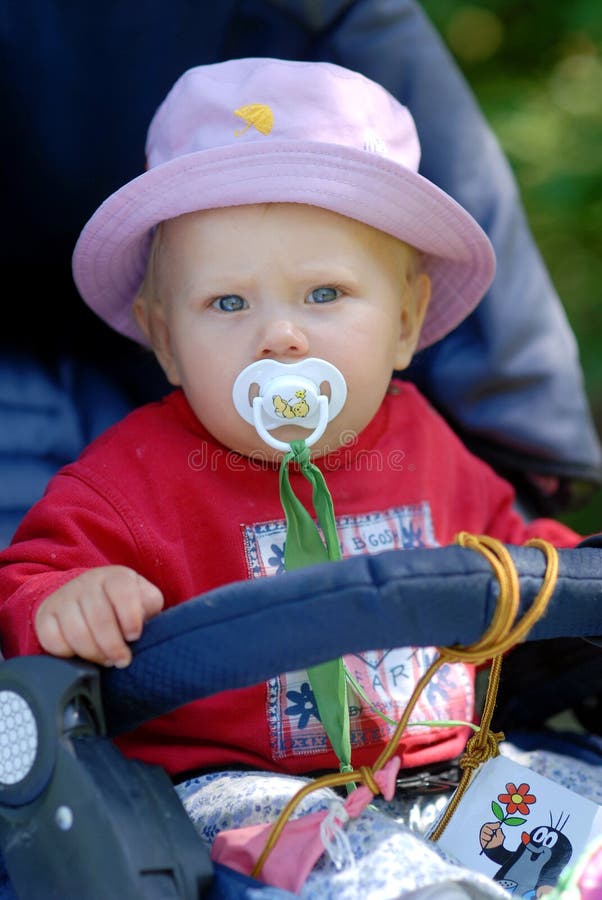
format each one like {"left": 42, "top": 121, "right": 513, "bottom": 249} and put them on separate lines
{"left": 0, "top": 541, "right": 602, "bottom": 900}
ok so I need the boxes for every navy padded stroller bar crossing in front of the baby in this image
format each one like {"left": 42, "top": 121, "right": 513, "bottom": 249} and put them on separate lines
{"left": 101, "top": 546, "right": 602, "bottom": 734}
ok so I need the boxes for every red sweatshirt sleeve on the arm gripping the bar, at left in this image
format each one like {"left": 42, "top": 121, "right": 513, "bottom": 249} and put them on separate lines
{"left": 0, "top": 467, "right": 144, "bottom": 657}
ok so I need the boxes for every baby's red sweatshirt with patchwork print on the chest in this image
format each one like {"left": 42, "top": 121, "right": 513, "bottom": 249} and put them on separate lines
{"left": 0, "top": 382, "right": 578, "bottom": 774}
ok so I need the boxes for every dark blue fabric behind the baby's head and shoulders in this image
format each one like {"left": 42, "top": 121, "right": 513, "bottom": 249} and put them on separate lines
{"left": 0, "top": 0, "right": 601, "bottom": 545}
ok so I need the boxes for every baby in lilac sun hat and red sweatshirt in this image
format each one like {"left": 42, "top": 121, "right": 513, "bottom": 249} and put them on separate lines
{"left": 0, "top": 59, "right": 578, "bottom": 900}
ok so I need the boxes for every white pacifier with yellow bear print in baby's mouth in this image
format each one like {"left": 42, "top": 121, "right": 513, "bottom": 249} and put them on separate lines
{"left": 232, "top": 357, "right": 347, "bottom": 452}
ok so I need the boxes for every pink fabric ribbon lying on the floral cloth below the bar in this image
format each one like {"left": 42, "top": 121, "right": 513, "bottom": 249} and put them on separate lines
{"left": 211, "top": 756, "right": 400, "bottom": 893}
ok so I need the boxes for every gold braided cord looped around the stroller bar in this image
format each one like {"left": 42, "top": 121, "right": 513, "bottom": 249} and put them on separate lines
{"left": 251, "top": 532, "right": 558, "bottom": 878}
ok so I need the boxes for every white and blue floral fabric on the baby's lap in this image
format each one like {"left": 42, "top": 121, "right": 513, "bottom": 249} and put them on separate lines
{"left": 176, "top": 744, "right": 602, "bottom": 900}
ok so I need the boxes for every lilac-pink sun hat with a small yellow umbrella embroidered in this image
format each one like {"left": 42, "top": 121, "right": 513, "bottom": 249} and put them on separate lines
{"left": 73, "top": 58, "right": 495, "bottom": 348}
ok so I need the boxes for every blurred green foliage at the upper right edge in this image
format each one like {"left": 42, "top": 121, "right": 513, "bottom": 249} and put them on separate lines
{"left": 422, "top": 0, "right": 602, "bottom": 533}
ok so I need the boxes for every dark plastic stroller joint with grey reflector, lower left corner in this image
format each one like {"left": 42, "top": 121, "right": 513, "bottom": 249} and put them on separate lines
{"left": 0, "top": 656, "right": 212, "bottom": 900}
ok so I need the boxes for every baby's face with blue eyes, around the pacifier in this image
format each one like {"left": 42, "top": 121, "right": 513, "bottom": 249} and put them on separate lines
{"left": 137, "top": 203, "right": 429, "bottom": 459}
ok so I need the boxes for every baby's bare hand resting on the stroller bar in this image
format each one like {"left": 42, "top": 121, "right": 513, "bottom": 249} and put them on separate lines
{"left": 35, "top": 566, "right": 163, "bottom": 668}
